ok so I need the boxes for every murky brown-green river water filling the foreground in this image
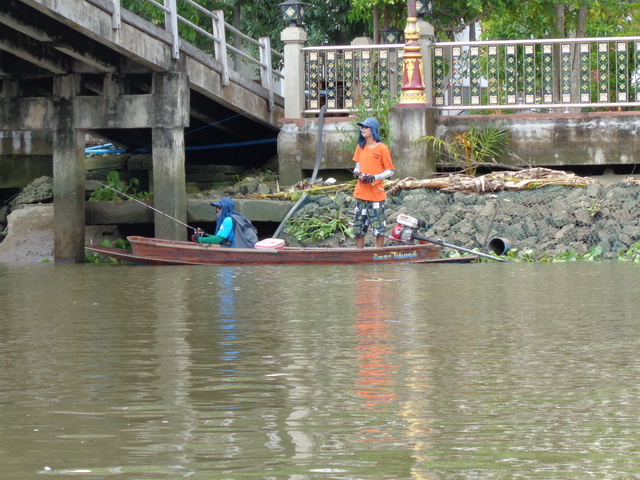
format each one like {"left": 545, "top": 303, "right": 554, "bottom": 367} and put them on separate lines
{"left": 0, "top": 263, "right": 640, "bottom": 480}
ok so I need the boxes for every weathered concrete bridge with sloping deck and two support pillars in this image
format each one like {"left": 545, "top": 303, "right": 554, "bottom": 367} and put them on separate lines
{"left": 0, "top": 0, "right": 284, "bottom": 263}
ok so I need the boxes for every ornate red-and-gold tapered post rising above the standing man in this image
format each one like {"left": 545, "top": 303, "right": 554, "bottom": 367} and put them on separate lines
{"left": 398, "top": 0, "right": 433, "bottom": 107}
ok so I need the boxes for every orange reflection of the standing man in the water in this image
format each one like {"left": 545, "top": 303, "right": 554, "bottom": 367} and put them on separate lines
{"left": 355, "top": 278, "right": 396, "bottom": 407}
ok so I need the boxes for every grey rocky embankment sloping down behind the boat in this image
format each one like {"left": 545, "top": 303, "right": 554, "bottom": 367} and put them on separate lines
{"left": 285, "top": 175, "right": 640, "bottom": 259}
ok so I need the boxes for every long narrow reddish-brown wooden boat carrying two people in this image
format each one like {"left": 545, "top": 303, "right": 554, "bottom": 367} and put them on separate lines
{"left": 85, "top": 236, "right": 476, "bottom": 265}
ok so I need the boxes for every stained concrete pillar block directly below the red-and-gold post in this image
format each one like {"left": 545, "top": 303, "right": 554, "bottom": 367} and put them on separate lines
{"left": 389, "top": 107, "right": 436, "bottom": 179}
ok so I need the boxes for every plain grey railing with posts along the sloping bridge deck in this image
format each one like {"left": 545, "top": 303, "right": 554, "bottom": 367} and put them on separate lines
{"left": 105, "top": 0, "right": 284, "bottom": 110}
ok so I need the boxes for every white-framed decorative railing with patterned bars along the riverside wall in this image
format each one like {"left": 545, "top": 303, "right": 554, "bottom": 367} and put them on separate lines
{"left": 302, "top": 37, "right": 640, "bottom": 115}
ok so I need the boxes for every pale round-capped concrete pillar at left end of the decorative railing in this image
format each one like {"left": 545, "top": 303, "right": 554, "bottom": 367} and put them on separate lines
{"left": 280, "top": 27, "right": 307, "bottom": 118}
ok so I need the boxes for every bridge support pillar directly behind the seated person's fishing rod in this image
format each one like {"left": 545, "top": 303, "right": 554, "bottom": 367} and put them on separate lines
{"left": 151, "top": 72, "right": 189, "bottom": 240}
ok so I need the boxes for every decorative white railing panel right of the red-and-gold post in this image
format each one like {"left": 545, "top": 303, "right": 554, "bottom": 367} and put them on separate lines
{"left": 426, "top": 37, "right": 640, "bottom": 113}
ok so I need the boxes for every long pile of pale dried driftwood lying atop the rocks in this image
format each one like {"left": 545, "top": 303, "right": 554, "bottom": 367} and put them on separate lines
{"left": 388, "top": 168, "right": 595, "bottom": 195}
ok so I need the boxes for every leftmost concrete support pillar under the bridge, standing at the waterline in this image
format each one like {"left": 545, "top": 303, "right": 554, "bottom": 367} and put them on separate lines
{"left": 53, "top": 74, "right": 85, "bottom": 263}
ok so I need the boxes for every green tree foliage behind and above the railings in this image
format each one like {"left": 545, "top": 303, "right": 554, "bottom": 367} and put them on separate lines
{"left": 122, "top": 0, "right": 640, "bottom": 50}
